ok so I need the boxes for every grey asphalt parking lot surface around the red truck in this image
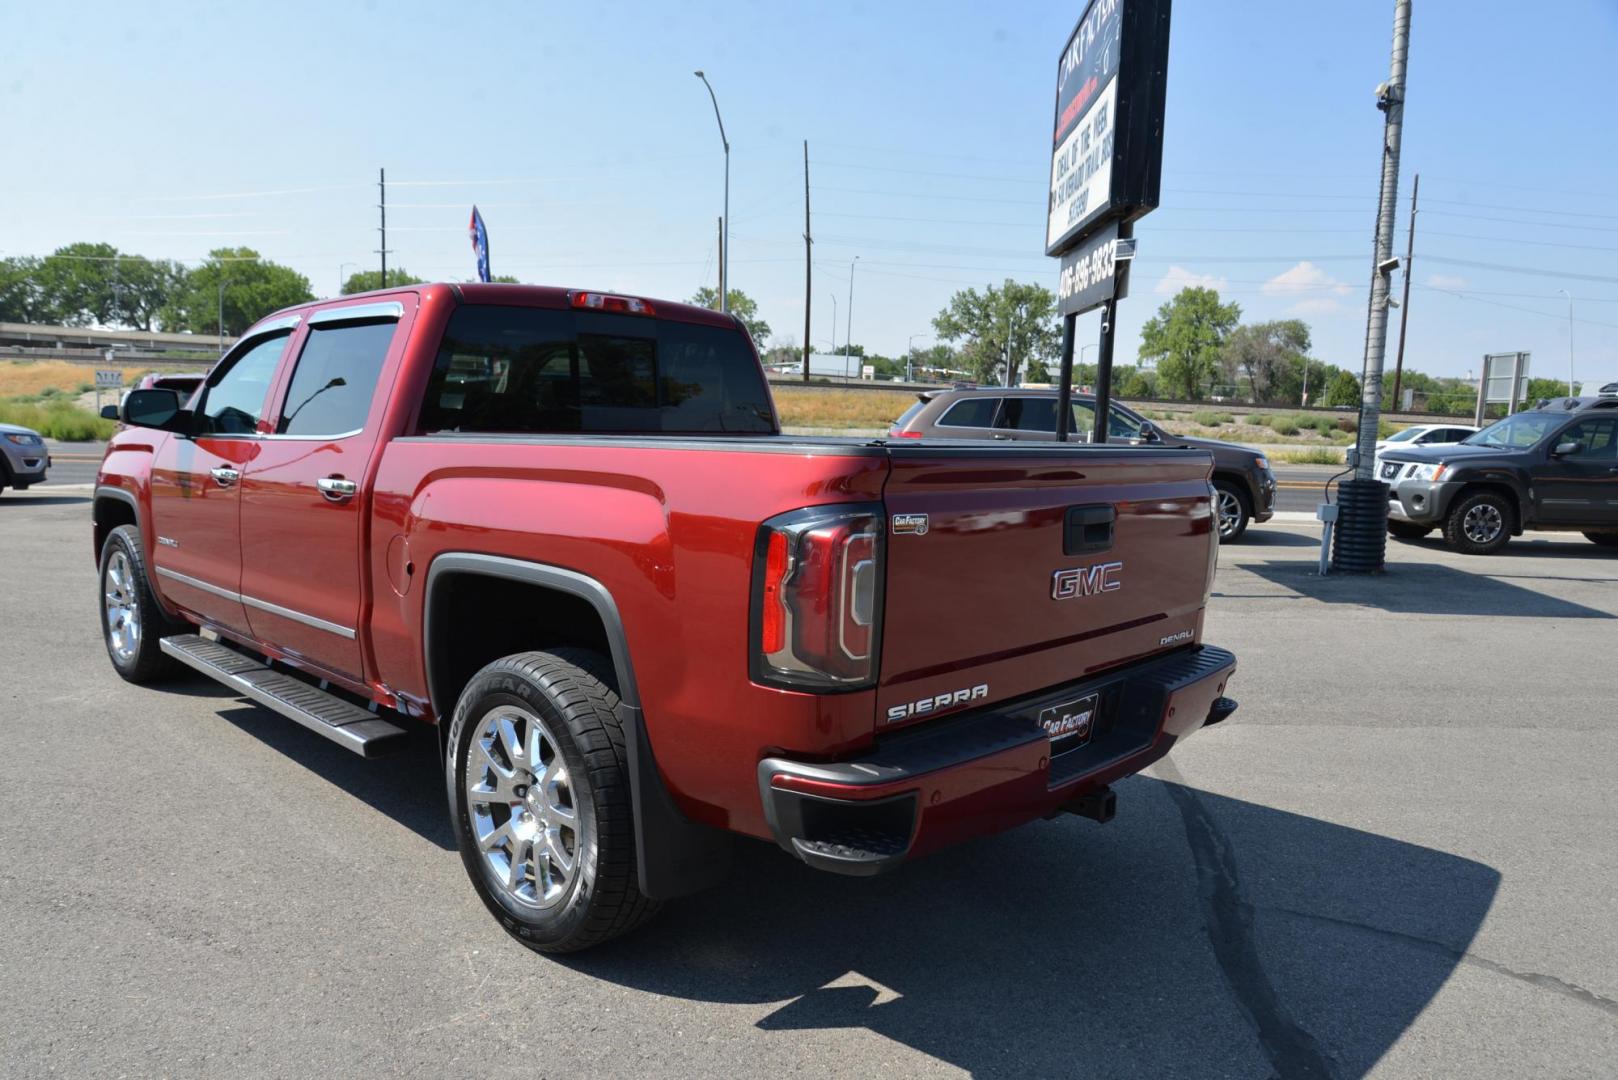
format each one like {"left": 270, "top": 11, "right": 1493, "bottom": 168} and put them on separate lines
{"left": 0, "top": 487, "right": 1618, "bottom": 1077}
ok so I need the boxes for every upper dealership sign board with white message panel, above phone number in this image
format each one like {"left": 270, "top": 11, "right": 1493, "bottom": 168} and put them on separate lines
{"left": 1045, "top": 0, "right": 1170, "bottom": 256}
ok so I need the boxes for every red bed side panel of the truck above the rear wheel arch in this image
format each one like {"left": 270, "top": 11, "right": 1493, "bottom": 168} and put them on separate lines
{"left": 367, "top": 436, "right": 887, "bottom": 836}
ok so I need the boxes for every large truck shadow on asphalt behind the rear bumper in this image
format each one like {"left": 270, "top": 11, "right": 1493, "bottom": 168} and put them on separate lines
{"left": 561, "top": 777, "right": 1500, "bottom": 1077}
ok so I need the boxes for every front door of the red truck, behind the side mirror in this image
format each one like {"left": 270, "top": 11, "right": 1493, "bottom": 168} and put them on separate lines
{"left": 150, "top": 330, "right": 291, "bottom": 635}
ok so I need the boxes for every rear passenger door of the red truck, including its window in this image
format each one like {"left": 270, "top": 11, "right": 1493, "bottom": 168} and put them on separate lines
{"left": 241, "top": 296, "right": 414, "bottom": 682}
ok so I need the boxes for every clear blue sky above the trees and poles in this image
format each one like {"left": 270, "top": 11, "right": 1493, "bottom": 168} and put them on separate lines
{"left": 0, "top": 0, "right": 1618, "bottom": 379}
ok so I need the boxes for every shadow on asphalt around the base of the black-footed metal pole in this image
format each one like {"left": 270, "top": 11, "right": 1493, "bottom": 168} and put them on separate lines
{"left": 1239, "top": 562, "right": 1615, "bottom": 619}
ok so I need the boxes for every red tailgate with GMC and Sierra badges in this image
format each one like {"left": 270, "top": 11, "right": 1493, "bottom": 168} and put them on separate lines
{"left": 877, "top": 444, "right": 1218, "bottom": 729}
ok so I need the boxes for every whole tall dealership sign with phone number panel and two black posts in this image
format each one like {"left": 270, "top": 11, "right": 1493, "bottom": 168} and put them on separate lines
{"left": 1045, "top": 0, "right": 1170, "bottom": 442}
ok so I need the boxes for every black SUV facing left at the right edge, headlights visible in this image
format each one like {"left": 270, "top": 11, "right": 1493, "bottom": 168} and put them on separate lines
{"left": 1377, "top": 397, "right": 1618, "bottom": 555}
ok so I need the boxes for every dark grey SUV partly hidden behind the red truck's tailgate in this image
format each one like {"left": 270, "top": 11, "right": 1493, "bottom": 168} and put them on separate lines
{"left": 888, "top": 387, "right": 1275, "bottom": 541}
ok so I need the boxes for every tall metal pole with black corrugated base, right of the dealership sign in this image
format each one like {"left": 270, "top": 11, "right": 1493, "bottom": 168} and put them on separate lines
{"left": 1332, "top": 0, "right": 1411, "bottom": 573}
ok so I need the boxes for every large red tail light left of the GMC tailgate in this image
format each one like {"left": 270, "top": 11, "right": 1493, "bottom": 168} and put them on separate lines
{"left": 752, "top": 505, "right": 887, "bottom": 690}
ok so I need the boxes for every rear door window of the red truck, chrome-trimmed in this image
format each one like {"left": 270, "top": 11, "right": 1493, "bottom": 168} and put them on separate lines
{"left": 275, "top": 319, "right": 398, "bottom": 436}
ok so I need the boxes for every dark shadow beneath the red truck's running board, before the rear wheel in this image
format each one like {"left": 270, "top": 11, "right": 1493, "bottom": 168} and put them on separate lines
{"left": 218, "top": 702, "right": 455, "bottom": 852}
